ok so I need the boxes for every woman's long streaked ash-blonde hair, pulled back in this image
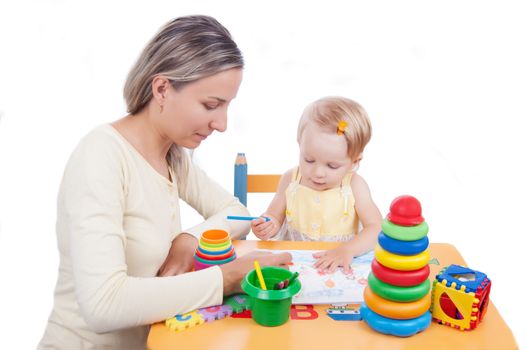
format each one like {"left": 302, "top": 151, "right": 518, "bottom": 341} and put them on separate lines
{"left": 124, "top": 15, "right": 244, "bottom": 184}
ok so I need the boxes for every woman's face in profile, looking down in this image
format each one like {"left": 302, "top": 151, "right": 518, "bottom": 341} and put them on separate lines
{"left": 159, "top": 68, "right": 243, "bottom": 148}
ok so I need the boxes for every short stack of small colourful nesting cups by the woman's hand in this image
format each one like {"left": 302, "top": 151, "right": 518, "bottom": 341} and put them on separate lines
{"left": 194, "top": 230, "right": 236, "bottom": 271}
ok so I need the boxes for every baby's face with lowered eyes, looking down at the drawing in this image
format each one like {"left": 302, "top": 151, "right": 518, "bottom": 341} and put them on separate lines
{"left": 299, "top": 124, "right": 353, "bottom": 191}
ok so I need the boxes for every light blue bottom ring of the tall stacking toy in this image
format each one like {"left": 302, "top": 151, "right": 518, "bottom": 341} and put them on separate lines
{"left": 360, "top": 303, "right": 431, "bottom": 337}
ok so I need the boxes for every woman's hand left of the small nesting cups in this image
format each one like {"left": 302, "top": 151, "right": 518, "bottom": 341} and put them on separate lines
{"left": 157, "top": 232, "right": 198, "bottom": 277}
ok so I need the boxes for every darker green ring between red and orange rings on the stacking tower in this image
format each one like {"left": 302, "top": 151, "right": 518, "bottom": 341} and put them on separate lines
{"left": 367, "top": 272, "right": 431, "bottom": 303}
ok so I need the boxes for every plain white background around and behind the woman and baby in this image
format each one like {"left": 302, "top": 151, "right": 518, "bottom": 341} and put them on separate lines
{"left": 0, "top": 0, "right": 526, "bottom": 349}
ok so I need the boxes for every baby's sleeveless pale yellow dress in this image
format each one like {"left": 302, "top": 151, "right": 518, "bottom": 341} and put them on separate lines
{"left": 275, "top": 168, "right": 359, "bottom": 242}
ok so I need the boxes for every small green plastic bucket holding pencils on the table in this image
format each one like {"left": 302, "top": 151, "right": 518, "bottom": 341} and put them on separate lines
{"left": 241, "top": 267, "right": 301, "bottom": 327}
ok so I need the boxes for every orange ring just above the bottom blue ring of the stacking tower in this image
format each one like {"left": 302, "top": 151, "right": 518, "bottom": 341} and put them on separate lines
{"left": 363, "top": 287, "right": 431, "bottom": 320}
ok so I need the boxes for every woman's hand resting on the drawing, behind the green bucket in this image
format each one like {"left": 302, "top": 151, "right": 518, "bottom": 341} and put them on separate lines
{"left": 219, "top": 252, "right": 292, "bottom": 295}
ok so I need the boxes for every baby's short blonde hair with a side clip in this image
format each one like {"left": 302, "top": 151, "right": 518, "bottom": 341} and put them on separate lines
{"left": 298, "top": 96, "right": 371, "bottom": 162}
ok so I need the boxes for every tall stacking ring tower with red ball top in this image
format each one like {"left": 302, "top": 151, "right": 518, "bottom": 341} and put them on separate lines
{"left": 360, "top": 196, "right": 431, "bottom": 337}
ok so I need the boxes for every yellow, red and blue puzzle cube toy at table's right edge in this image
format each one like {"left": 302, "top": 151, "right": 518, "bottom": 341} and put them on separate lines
{"left": 431, "top": 265, "right": 491, "bottom": 331}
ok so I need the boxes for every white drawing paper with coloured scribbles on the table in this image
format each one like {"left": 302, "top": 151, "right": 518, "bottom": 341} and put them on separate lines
{"left": 260, "top": 250, "right": 374, "bottom": 304}
